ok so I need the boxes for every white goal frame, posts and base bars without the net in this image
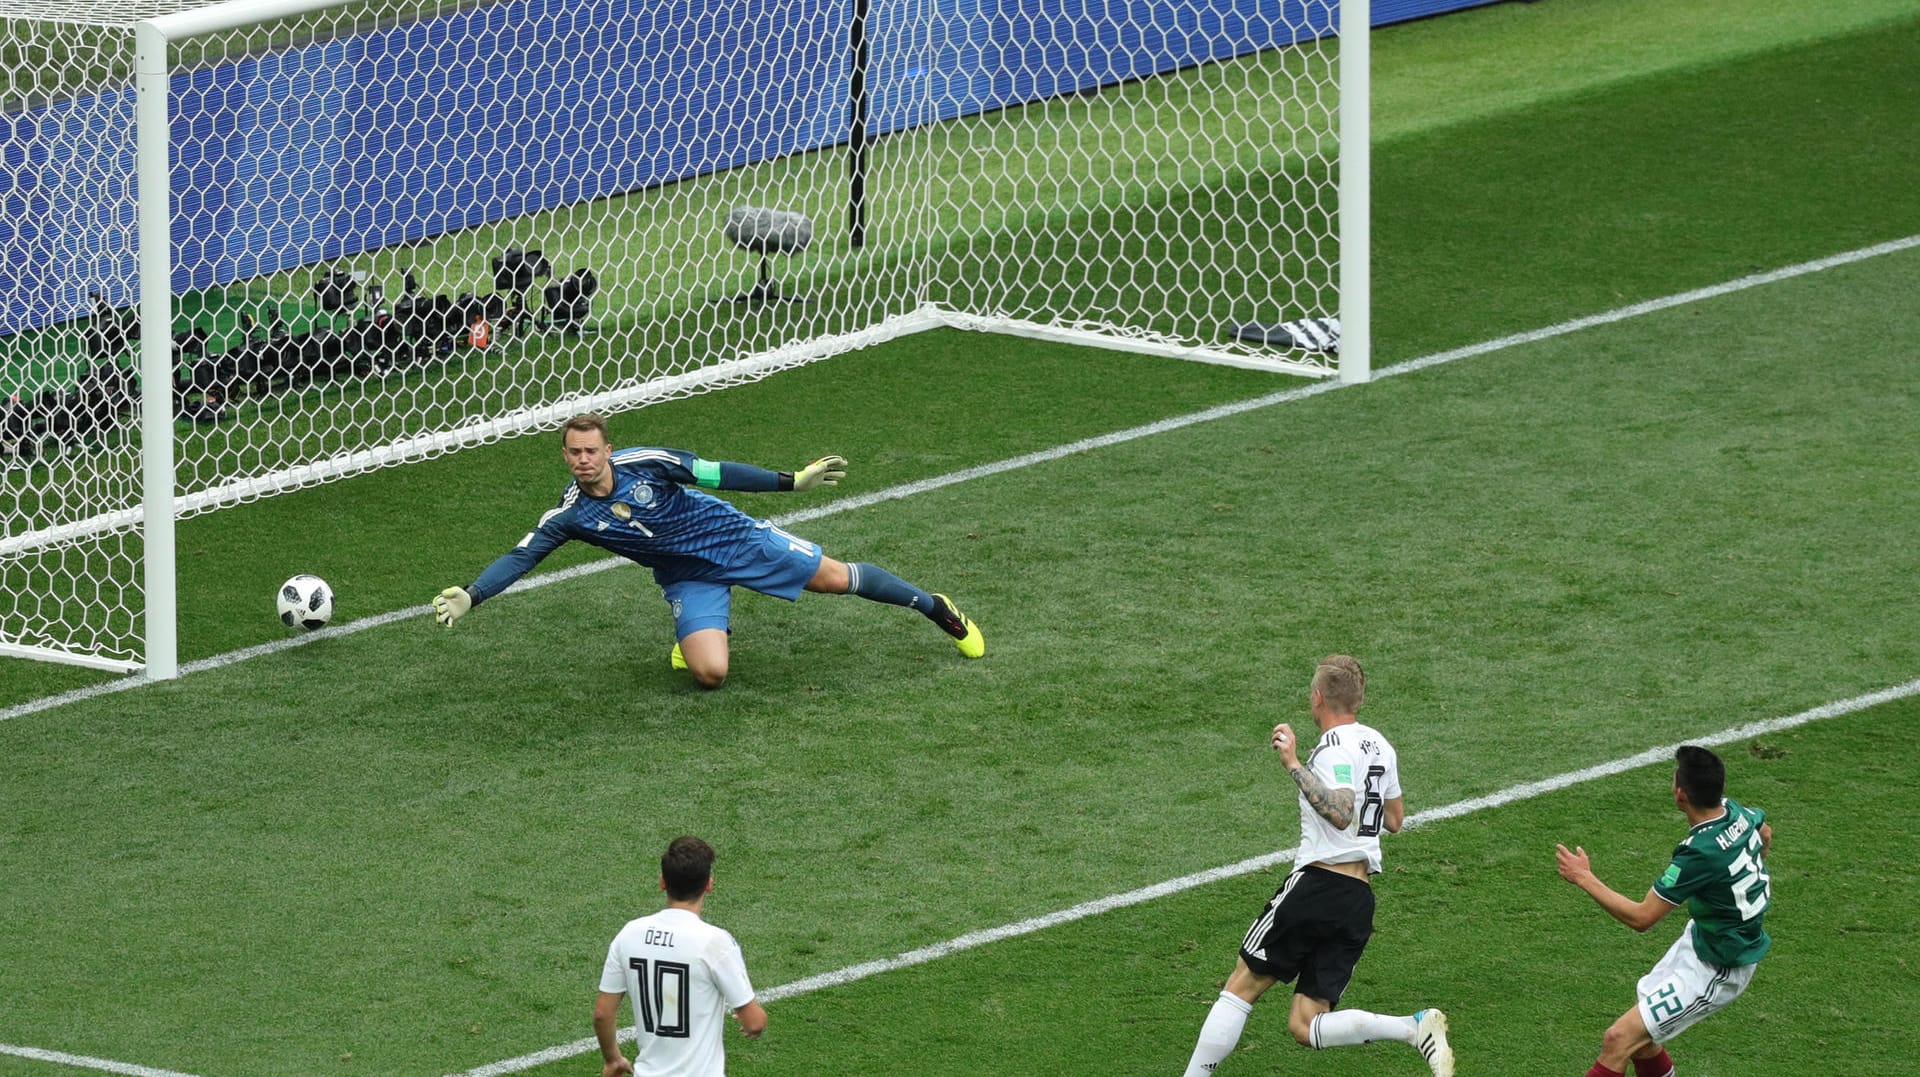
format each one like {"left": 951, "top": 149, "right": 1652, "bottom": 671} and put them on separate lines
{"left": 0, "top": 0, "right": 1373, "bottom": 680}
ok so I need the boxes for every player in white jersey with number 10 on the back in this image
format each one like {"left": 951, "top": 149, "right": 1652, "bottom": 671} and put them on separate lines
{"left": 593, "top": 837, "right": 766, "bottom": 1077}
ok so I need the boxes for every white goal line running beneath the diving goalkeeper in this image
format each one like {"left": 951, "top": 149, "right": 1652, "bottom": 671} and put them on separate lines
{"left": 0, "top": 236, "right": 1920, "bottom": 722}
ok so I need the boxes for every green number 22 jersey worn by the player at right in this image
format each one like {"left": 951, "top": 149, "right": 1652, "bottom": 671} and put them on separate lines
{"left": 1653, "top": 801, "right": 1774, "bottom": 968}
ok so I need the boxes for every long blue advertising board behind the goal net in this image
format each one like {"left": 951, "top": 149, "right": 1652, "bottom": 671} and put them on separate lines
{"left": 0, "top": 0, "right": 1488, "bottom": 334}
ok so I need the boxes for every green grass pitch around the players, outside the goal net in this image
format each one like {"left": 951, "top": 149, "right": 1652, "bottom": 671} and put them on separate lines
{"left": 0, "top": 0, "right": 1920, "bottom": 1077}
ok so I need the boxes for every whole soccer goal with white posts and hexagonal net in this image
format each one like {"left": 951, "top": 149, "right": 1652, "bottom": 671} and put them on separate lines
{"left": 0, "top": 0, "right": 1369, "bottom": 678}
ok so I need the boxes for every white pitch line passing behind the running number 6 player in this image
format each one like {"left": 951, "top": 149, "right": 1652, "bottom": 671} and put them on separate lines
{"left": 455, "top": 680, "right": 1920, "bottom": 1077}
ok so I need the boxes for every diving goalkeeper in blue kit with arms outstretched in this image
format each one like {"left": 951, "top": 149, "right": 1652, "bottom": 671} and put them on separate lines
{"left": 434, "top": 415, "right": 987, "bottom": 687}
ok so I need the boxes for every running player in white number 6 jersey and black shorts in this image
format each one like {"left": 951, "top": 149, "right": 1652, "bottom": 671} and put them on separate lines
{"left": 1187, "top": 655, "right": 1453, "bottom": 1077}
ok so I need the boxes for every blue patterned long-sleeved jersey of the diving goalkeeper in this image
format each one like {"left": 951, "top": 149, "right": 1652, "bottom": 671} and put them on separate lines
{"left": 467, "top": 449, "right": 780, "bottom": 603}
